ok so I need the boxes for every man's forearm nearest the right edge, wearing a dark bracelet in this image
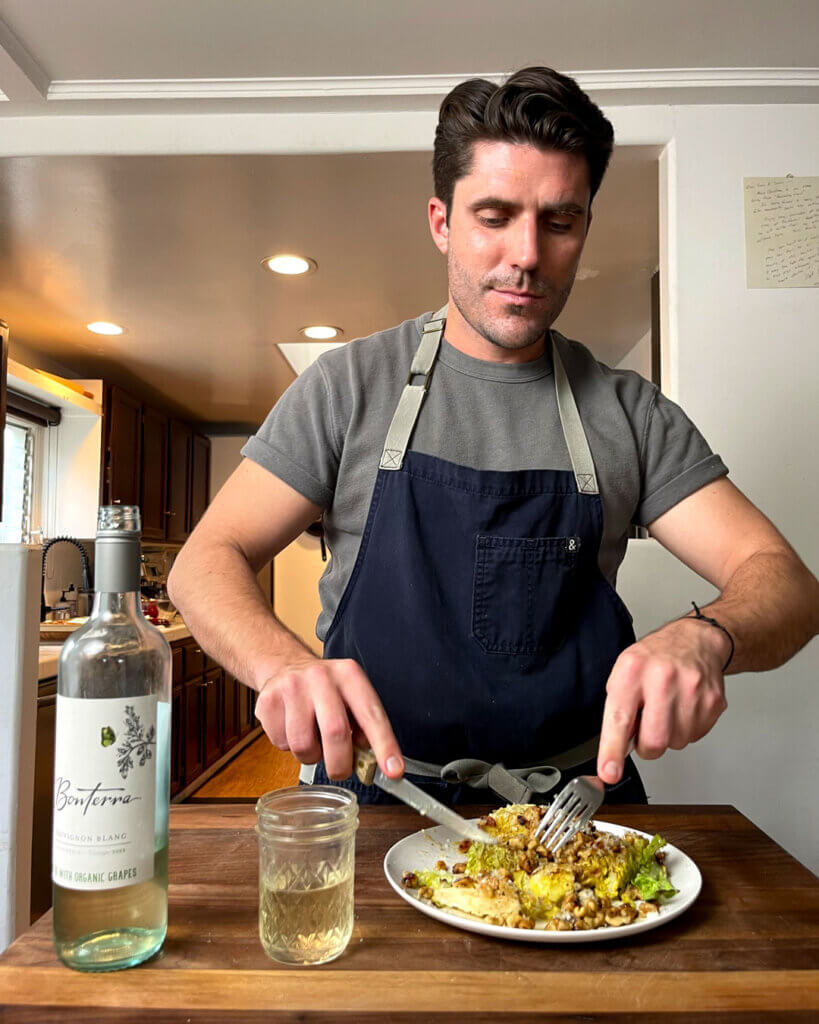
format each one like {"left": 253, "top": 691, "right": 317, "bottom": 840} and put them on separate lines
{"left": 697, "top": 549, "right": 819, "bottom": 675}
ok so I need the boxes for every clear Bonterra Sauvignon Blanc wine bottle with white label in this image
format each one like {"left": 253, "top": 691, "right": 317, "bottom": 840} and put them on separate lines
{"left": 51, "top": 505, "right": 171, "bottom": 971}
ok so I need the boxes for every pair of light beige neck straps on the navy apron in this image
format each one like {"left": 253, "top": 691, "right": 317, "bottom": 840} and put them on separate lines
{"left": 380, "top": 303, "right": 598, "bottom": 495}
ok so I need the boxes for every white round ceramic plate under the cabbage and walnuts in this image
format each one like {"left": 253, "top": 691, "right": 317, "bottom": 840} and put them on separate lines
{"left": 384, "top": 819, "right": 702, "bottom": 942}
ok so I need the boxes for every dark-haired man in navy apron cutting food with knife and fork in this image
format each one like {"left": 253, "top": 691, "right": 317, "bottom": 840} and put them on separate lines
{"left": 169, "top": 68, "right": 819, "bottom": 803}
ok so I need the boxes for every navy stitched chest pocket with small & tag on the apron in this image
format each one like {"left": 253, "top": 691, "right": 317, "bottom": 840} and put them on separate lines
{"left": 472, "top": 534, "right": 580, "bottom": 654}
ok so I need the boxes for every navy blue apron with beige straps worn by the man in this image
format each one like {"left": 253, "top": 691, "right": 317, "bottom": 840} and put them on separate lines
{"left": 301, "top": 306, "right": 645, "bottom": 804}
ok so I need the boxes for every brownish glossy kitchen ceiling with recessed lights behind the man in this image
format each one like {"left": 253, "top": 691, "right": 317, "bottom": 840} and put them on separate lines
{"left": 0, "top": 146, "right": 658, "bottom": 423}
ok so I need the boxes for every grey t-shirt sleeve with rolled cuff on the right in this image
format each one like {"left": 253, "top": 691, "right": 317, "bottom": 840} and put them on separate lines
{"left": 634, "top": 388, "right": 728, "bottom": 526}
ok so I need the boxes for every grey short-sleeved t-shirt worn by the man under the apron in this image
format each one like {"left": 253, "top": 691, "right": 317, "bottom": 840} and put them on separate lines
{"left": 242, "top": 312, "right": 728, "bottom": 640}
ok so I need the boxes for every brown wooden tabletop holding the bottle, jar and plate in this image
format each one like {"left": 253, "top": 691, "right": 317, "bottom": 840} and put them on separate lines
{"left": 0, "top": 804, "right": 819, "bottom": 1024}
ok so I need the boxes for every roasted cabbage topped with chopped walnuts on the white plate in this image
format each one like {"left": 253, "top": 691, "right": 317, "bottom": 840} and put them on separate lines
{"left": 403, "top": 804, "right": 677, "bottom": 931}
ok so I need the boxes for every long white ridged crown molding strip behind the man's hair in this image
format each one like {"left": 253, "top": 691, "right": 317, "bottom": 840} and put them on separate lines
{"left": 46, "top": 68, "right": 819, "bottom": 102}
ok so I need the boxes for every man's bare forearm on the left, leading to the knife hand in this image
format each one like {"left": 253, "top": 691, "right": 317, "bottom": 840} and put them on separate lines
{"left": 168, "top": 540, "right": 315, "bottom": 690}
